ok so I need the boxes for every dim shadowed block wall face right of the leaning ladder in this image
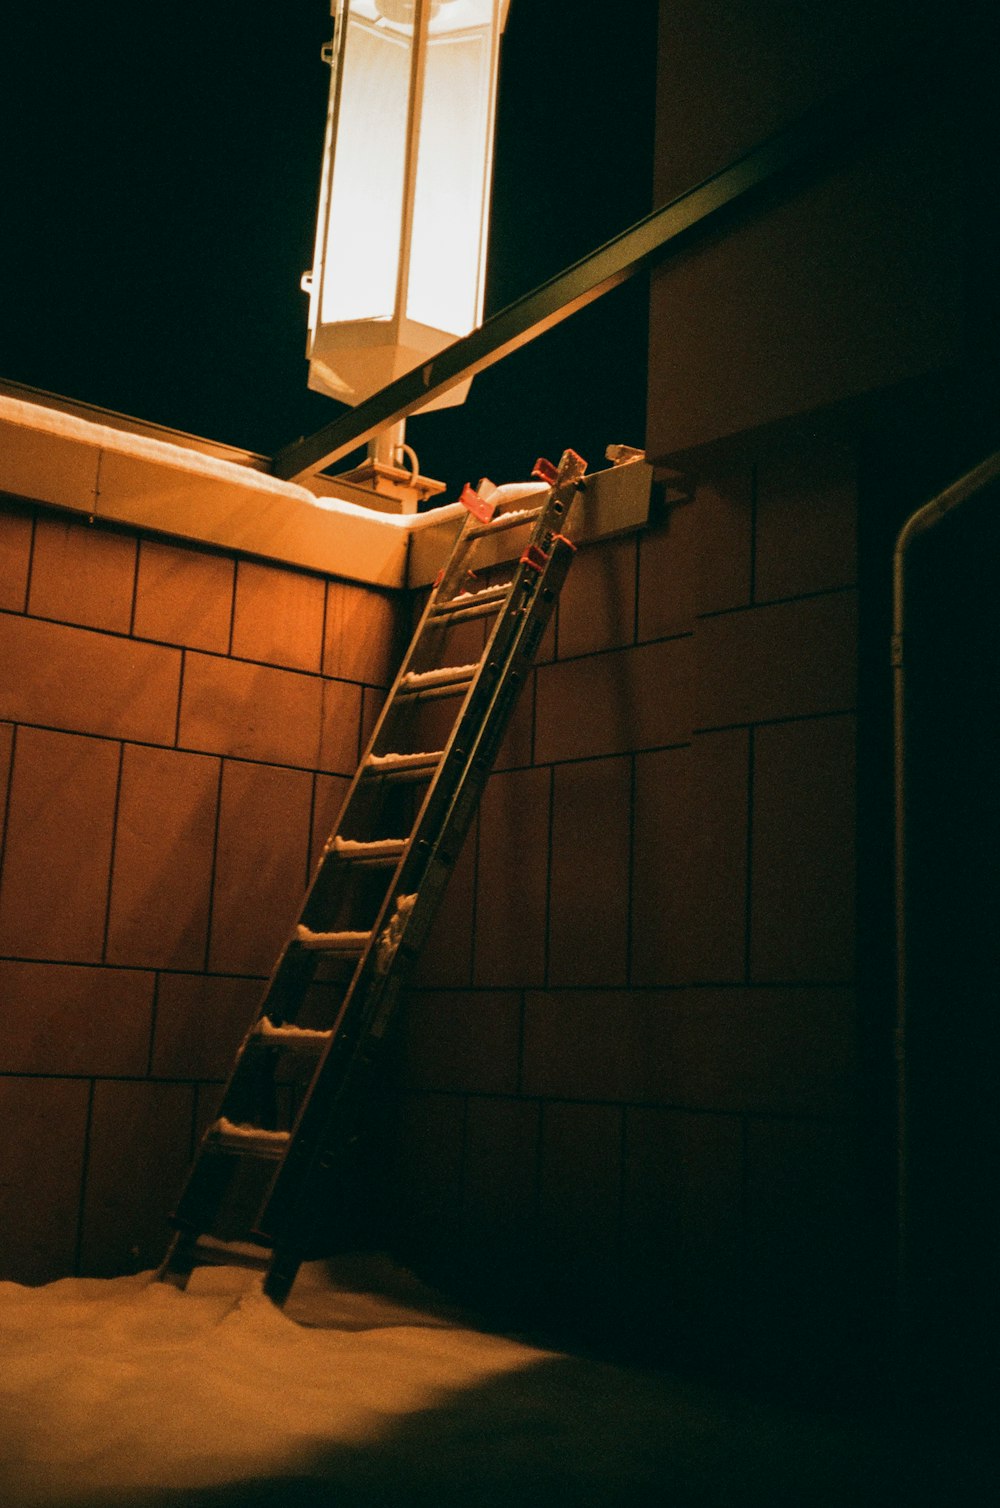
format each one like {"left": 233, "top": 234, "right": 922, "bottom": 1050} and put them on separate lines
{"left": 395, "top": 440, "right": 863, "bottom": 1369}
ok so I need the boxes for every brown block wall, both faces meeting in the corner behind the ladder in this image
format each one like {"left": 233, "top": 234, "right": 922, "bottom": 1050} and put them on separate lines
{"left": 0, "top": 442, "right": 861, "bottom": 1366}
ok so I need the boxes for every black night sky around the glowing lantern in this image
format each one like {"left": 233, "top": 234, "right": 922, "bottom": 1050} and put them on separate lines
{"left": 0, "top": 0, "right": 658, "bottom": 486}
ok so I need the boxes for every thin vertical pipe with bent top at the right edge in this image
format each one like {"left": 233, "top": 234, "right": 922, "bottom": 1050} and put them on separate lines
{"left": 891, "top": 451, "right": 1000, "bottom": 1342}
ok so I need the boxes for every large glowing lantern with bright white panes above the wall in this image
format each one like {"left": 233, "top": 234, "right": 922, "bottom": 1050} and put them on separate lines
{"left": 306, "top": 0, "right": 507, "bottom": 403}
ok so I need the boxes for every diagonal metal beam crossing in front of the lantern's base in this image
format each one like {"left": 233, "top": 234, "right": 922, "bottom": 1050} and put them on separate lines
{"left": 271, "top": 60, "right": 919, "bottom": 481}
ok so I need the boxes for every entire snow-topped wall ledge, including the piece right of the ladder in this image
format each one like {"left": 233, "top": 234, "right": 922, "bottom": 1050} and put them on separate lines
{"left": 0, "top": 385, "right": 653, "bottom": 587}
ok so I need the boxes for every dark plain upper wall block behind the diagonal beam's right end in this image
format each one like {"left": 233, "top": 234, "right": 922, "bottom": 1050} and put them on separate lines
{"left": 646, "top": 0, "right": 965, "bottom": 458}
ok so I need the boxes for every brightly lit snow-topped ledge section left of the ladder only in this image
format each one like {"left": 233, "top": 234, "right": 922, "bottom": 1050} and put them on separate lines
{"left": 0, "top": 394, "right": 462, "bottom": 587}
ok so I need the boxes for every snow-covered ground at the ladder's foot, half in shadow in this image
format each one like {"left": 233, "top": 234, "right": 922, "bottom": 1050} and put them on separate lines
{"left": 0, "top": 1264, "right": 977, "bottom": 1508}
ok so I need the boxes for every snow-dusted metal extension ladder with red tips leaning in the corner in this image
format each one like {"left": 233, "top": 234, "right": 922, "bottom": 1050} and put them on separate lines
{"left": 160, "top": 451, "right": 585, "bottom": 1304}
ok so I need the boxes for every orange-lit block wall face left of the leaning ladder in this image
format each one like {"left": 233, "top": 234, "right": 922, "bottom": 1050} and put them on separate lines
{"left": 0, "top": 499, "right": 400, "bottom": 1282}
